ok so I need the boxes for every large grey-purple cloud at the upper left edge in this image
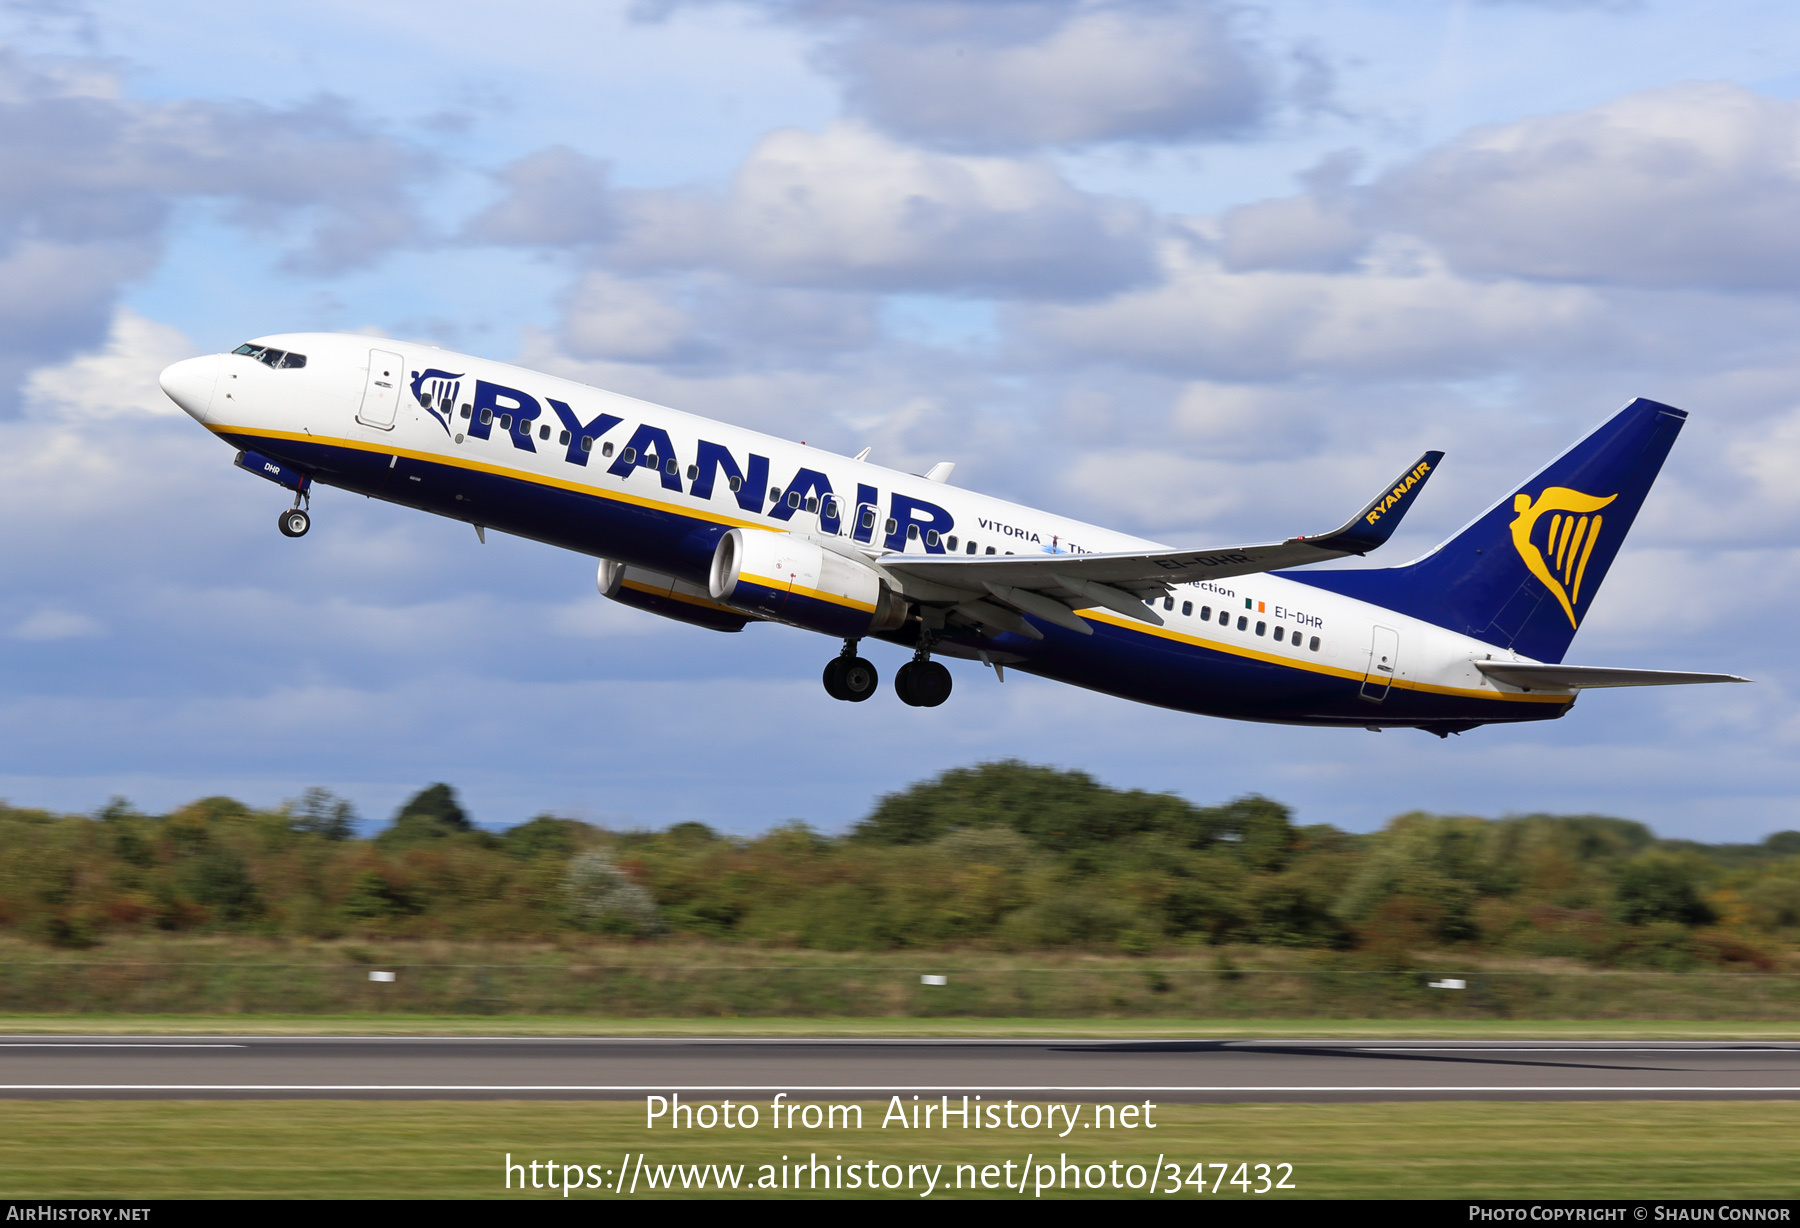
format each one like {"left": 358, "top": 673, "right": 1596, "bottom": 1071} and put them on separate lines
{"left": 0, "top": 47, "right": 434, "bottom": 407}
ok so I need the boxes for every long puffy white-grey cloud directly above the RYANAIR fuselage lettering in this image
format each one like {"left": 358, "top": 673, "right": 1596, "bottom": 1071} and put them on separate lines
{"left": 472, "top": 122, "right": 1152, "bottom": 297}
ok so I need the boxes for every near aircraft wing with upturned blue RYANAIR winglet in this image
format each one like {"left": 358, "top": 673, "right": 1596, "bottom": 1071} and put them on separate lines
{"left": 875, "top": 452, "right": 1444, "bottom": 634}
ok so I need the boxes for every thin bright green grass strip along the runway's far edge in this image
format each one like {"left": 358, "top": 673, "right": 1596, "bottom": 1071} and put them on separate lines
{"left": 0, "top": 1014, "right": 1800, "bottom": 1041}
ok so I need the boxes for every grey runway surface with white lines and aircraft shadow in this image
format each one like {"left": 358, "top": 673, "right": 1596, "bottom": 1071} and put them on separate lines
{"left": 0, "top": 1035, "right": 1800, "bottom": 1102}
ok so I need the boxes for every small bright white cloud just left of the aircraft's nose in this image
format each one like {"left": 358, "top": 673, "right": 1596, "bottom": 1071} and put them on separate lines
{"left": 23, "top": 306, "right": 194, "bottom": 418}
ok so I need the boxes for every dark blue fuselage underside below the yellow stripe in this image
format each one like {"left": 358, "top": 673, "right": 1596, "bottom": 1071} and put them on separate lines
{"left": 232, "top": 432, "right": 1573, "bottom": 733}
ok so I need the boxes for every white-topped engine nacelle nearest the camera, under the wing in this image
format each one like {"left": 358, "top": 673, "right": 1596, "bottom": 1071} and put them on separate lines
{"left": 707, "top": 529, "right": 905, "bottom": 639}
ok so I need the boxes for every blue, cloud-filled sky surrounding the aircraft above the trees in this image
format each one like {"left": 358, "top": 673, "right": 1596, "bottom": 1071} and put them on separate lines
{"left": 0, "top": 0, "right": 1800, "bottom": 841}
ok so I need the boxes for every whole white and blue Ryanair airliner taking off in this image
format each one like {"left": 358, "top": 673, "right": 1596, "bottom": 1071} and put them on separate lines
{"left": 162, "top": 333, "right": 1742, "bottom": 736}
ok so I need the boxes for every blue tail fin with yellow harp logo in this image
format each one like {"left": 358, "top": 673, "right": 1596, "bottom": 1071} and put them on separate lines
{"left": 1282, "top": 398, "right": 1687, "bottom": 661}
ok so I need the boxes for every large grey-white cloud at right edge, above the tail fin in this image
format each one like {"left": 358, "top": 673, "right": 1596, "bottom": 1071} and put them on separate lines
{"left": 1366, "top": 83, "right": 1800, "bottom": 290}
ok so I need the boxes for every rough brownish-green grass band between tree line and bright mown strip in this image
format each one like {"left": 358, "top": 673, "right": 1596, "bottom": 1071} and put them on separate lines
{"left": 10, "top": 936, "right": 1800, "bottom": 1032}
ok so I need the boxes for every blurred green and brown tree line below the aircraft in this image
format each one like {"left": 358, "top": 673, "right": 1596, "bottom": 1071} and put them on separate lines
{"left": 0, "top": 760, "right": 1800, "bottom": 967}
